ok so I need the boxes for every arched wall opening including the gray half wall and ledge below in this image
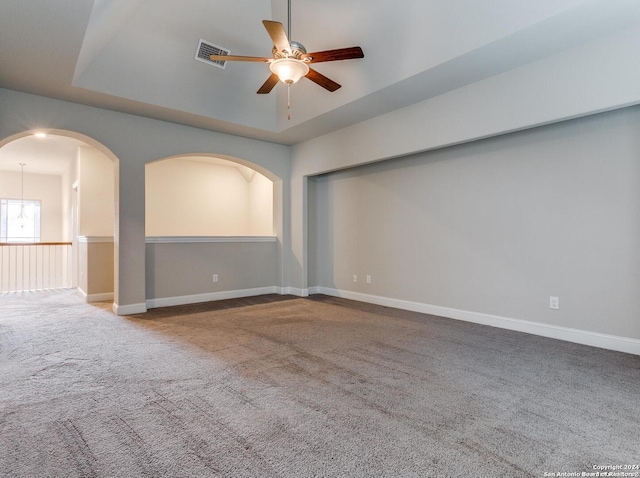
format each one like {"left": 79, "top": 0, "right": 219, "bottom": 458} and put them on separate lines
{"left": 145, "top": 153, "right": 283, "bottom": 308}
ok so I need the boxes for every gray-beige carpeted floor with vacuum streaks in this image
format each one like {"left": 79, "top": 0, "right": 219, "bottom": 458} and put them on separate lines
{"left": 0, "top": 291, "right": 640, "bottom": 478}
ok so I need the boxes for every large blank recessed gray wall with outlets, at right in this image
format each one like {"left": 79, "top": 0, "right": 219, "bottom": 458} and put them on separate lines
{"left": 308, "top": 107, "right": 640, "bottom": 339}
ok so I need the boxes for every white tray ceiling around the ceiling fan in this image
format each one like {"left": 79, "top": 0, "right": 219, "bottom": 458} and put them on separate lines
{"left": 0, "top": 0, "right": 640, "bottom": 172}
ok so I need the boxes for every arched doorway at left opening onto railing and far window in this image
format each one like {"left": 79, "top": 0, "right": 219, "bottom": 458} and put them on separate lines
{"left": 0, "top": 129, "right": 118, "bottom": 302}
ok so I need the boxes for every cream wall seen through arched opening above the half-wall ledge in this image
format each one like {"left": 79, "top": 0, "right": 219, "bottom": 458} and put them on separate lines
{"left": 145, "top": 158, "right": 273, "bottom": 236}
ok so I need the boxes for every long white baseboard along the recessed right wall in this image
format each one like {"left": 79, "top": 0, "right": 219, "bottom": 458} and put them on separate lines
{"left": 309, "top": 287, "right": 640, "bottom": 355}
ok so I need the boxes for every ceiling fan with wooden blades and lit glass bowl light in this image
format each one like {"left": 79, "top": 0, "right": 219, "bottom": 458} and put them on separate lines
{"left": 210, "top": 0, "right": 364, "bottom": 95}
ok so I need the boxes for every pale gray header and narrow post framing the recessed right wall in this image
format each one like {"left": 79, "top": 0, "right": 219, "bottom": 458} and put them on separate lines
{"left": 290, "top": 26, "right": 640, "bottom": 291}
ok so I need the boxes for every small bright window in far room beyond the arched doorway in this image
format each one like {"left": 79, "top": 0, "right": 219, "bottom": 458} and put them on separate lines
{"left": 0, "top": 199, "right": 40, "bottom": 242}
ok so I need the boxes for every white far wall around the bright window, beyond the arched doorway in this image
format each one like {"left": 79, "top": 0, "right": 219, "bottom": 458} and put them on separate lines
{"left": 0, "top": 171, "right": 65, "bottom": 242}
